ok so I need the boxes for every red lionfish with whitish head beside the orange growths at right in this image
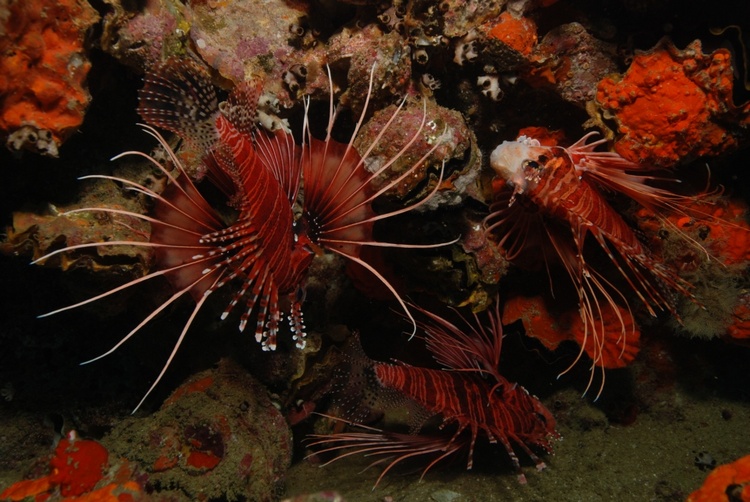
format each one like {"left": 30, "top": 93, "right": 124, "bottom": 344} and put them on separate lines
{"left": 485, "top": 132, "right": 736, "bottom": 397}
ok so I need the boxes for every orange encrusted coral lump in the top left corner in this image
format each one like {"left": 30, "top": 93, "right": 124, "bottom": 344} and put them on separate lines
{"left": 0, "top": 0, "right": 99, "bottom": 157}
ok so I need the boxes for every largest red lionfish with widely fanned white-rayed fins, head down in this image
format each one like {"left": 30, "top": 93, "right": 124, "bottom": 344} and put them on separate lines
{"left": 34, "top": 60, "right": 456, "bottom": 411}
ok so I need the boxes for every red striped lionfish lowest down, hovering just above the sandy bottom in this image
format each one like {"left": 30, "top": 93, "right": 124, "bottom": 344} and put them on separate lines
{"left": 309, "top": 302, "right": 559, "bottom": 486}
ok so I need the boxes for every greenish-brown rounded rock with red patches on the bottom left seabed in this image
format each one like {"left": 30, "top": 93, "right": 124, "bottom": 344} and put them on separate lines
{"left": 105, "top": 360, "right": 292, "bottom": 500}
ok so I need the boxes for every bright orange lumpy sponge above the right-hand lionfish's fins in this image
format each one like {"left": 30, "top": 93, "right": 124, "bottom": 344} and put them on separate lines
{"left": 596, "top": 39, "right": 744, "bottom": 167}
